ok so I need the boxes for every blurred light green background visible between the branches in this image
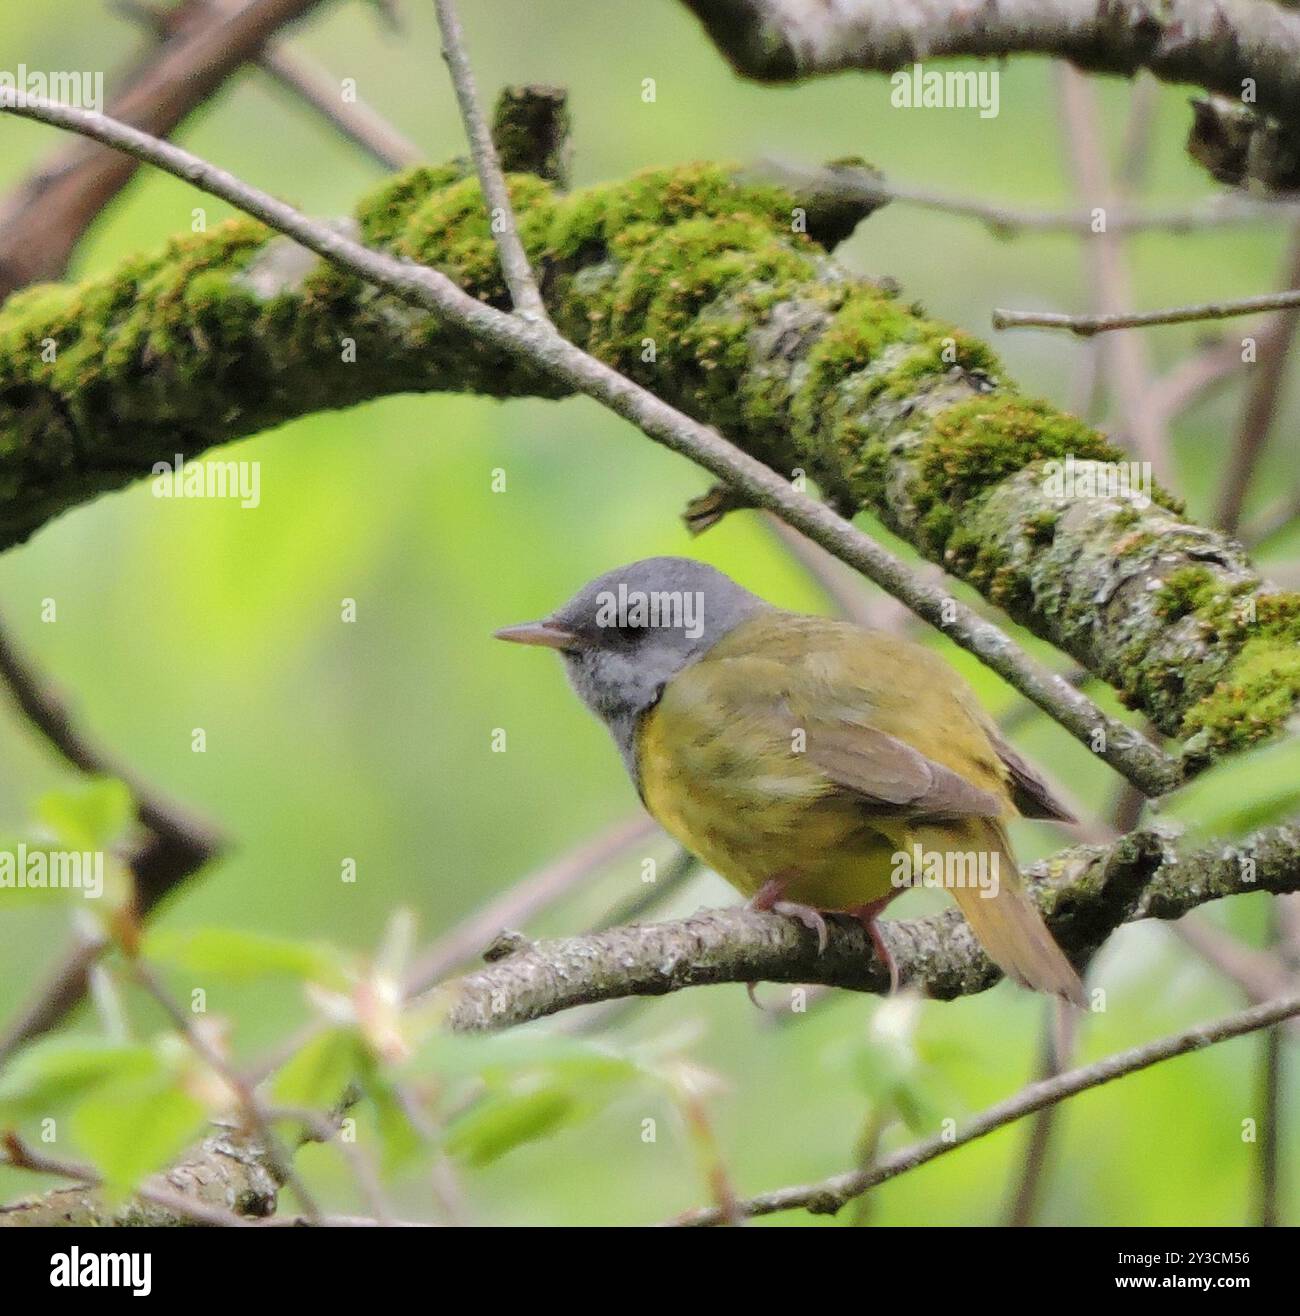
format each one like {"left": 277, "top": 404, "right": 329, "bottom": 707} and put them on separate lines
{"left": 0, "top": 0, "right": 1300, "bottom": 1225}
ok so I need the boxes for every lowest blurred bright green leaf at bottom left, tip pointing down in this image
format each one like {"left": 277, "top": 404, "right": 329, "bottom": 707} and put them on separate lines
{"left": 71, "top": 1075, "right": 207, "bottom": 1194}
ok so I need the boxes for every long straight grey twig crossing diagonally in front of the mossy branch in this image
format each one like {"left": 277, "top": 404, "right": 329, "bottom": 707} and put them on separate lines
{"left": 0, "top": 93, "right": 1183, "bottom": 795}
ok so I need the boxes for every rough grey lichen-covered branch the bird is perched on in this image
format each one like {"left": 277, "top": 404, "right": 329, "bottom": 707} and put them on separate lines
{"left": 436, "top": 826, "right": 1300, "bottom": 1032}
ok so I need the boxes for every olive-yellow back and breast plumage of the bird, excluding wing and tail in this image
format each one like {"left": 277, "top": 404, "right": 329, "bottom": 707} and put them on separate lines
{"left": 637, "top": 609, "right": 1004, "bottom": 909}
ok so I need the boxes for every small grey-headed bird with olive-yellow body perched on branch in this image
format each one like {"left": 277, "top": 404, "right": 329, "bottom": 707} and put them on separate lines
{"left": 497, "top": 558, "right": 1083, "bottom": 1004}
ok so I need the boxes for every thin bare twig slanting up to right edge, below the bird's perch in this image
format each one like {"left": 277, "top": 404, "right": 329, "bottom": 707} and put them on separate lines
{"left": 668, "top": 994, "right": 1300, "bottom": 1225}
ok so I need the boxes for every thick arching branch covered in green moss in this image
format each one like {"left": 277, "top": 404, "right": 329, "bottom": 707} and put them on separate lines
{"left": 0, "top": 153, "right": 1300, "bottom": 770}
